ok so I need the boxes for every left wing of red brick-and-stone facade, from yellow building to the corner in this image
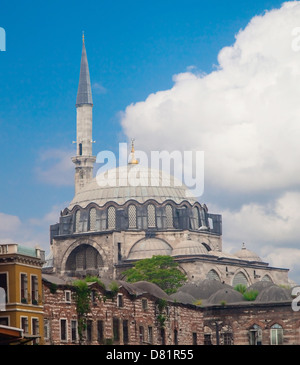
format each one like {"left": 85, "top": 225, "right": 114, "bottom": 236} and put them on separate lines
{"left": 44, "top": 277, "right": 203, "bottom": 345}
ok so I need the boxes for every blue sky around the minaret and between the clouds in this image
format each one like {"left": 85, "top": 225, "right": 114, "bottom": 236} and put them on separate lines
{"left": 0, "top": 0, "right": 300, "bottom": 277}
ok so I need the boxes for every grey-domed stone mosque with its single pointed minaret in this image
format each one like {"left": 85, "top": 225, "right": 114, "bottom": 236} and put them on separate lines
{"left": 43, "top": 38, "right": 289, "bottom": 286}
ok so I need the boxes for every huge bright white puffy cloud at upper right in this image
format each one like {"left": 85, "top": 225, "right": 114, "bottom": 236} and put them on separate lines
{"left": 122, "top": 2, "right": 300, "bottom": 196}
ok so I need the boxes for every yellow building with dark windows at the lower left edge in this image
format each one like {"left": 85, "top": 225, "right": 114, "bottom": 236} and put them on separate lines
{"left": 0, "top": 244, "right": 44, "bottom": 344}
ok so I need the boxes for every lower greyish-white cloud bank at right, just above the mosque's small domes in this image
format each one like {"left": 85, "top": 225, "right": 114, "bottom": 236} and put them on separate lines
{"left": 209, "top": 192, "right": 300, "bottom": 283}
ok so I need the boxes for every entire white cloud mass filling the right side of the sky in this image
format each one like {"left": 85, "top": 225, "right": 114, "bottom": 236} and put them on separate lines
{"left": 121, "top": 1, "right": 300, "bottom": 282}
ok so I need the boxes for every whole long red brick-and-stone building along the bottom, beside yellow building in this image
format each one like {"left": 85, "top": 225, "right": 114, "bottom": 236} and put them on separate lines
{"left": 43, "top": 275, "right": 300, "bottom": 346}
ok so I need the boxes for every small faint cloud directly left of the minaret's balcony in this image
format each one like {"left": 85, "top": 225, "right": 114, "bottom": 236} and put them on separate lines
{"left": 35, "top": 149, "right": 74, "bottom": 186}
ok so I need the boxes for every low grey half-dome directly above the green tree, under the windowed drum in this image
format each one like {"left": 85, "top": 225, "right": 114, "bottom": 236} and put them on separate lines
{"left": 127, "top": 238, "right": 172, "bottom": 260}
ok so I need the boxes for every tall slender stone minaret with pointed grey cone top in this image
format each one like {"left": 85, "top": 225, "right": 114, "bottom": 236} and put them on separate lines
{"left": 72, "top": 34, "right": 96, "bottom": 194}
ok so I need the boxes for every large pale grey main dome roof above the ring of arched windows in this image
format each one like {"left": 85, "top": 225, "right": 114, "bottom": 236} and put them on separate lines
{"left": 69, "top": 165, "right": 196, "bottom": 209}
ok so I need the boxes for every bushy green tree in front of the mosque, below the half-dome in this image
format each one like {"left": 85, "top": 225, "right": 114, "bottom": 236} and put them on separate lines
{"left": 124, "top": 255, "right": 187, "bottom": 294}
